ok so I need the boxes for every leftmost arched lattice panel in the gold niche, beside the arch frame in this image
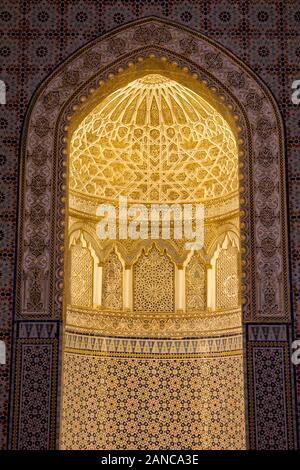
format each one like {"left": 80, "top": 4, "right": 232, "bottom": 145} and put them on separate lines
{"left": 70, "top": 243, "right": 94, "bottom": 307}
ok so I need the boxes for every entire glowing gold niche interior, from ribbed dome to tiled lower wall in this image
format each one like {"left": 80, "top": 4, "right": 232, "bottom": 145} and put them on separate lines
{"left": 60, "top": 64, "right": 246, "bottom": 450}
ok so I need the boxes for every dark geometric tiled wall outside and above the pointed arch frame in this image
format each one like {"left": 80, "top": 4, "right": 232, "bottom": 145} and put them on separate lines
{"left": 0, "top": 0, "right": 300, "bottom": 448}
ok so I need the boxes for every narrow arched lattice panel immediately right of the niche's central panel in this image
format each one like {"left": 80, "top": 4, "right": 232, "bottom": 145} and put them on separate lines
{"left": 185, "top": 254, "right": 207, "bottom": 312}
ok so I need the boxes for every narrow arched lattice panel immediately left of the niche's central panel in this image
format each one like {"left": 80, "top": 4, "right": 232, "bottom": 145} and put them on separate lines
{"left": 102, "top": 252, "right": 123, "bottom": 310}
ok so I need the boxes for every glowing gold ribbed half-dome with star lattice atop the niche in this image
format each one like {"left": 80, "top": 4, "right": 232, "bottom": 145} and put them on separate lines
{"left": 70, "top": 74, "right": 238, "bottom": 202}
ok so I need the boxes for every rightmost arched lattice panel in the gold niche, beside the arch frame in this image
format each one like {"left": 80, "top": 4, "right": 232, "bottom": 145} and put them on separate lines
{"left": 216, "top": 246, "right": 240, "bottom": 308}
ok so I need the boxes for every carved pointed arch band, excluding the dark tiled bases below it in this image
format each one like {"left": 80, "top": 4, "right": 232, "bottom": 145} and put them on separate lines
{"left": 16, "top": 21, "right": 289, "bottom": 321}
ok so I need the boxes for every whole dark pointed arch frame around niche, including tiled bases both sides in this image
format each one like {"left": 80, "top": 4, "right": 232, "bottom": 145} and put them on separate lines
{"left": 10, "top": 18, "right": 295, "bottom": 449}
